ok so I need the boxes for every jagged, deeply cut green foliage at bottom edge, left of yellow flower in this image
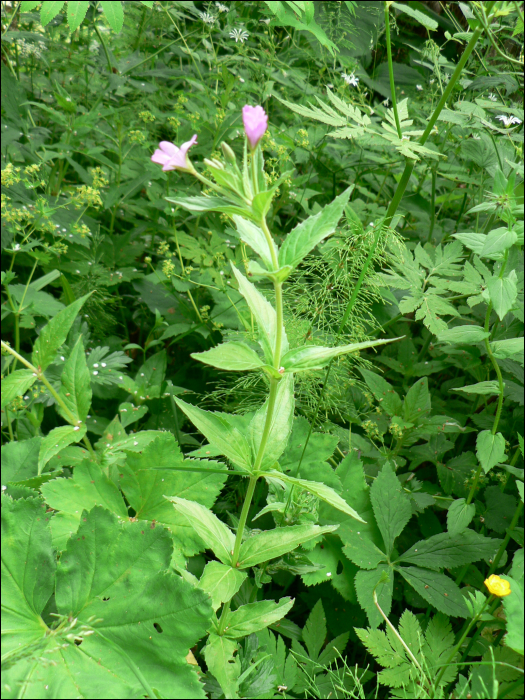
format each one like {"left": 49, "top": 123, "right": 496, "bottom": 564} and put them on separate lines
{"left": 355, "top": 610, "right": 457, "bottom": 698}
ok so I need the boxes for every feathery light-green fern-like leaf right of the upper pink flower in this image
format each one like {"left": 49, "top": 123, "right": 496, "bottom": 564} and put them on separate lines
{"left": 278, "top": 88, "right": 440, "bottom": 160}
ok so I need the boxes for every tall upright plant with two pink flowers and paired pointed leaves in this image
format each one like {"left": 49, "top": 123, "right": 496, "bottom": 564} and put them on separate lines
{"left": 149, "top": 105, "right": 396, "bottom": 697}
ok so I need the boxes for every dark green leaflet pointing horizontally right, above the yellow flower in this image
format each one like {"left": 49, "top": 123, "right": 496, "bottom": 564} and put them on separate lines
{"left": 396, "top": 530, "right": 501, "bottom": 571}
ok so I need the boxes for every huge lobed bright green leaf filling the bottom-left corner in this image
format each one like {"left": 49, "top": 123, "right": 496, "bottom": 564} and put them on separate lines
{"left": 2, "top": 499, "right": 212, "bottom": 698}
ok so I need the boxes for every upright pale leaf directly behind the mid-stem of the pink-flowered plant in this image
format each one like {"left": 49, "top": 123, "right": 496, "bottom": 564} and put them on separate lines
{"left": 248, "top": 374, "right": 295, "bottom": 470}
